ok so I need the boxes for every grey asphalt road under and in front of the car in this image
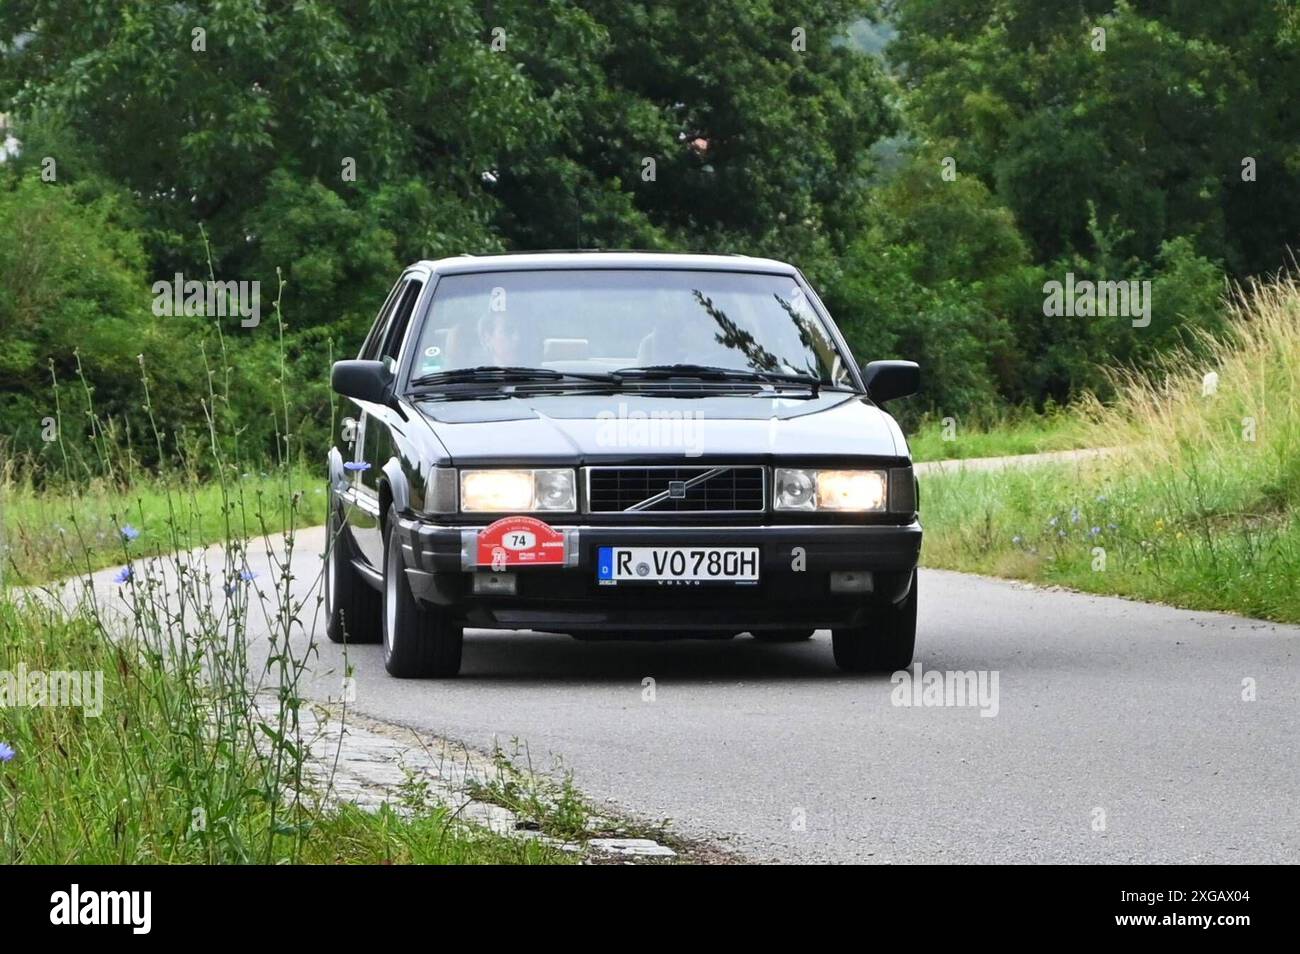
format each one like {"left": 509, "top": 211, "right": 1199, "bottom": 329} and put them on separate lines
{"left": 63, "top": 519, "right": 1300, "bottom": 863}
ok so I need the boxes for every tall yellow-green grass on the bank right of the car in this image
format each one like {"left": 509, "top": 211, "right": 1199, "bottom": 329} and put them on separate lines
{"left": 922, "top": 274, "right": 1300, "bottom": 621}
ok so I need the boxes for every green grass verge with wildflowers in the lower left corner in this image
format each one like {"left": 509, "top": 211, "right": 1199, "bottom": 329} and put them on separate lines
{"left": 0, "top": 600, "right": 572, "bottom": 864}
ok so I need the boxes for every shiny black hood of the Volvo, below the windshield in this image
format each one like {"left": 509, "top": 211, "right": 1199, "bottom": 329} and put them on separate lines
{"left": 415, "top": 391, "right": 907, "bottom": 464}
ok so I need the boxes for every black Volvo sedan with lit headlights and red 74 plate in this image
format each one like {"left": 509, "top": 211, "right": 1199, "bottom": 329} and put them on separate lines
{"left": 326, "top": 252, "right": 920, "bottom": 676}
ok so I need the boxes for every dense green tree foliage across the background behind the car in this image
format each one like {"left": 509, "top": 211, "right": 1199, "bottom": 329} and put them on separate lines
{"left": 0, "top": 0, "right": 1300, "bottom": 454}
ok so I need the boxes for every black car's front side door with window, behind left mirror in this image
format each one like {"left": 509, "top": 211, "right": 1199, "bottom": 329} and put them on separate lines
{"left": 352, "top": 273, "right": 424, "bottom": 569}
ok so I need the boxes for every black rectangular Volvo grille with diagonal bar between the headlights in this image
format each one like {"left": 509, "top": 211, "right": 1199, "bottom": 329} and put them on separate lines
{"left": 586, "top": 465, "right": 767, "bottom": 513}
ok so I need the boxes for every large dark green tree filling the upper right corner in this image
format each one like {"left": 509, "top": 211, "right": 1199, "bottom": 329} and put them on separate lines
{"left": 891, "top": 0, "right": 1300, "bottom": 274}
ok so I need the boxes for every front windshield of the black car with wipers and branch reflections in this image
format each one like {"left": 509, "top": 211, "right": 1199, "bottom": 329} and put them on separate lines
{"left": 411, "top": 269, "right": 852, "bottom": 387}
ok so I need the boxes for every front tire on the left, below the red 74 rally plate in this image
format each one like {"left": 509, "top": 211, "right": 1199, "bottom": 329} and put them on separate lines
{"left": 382, "top": 507, "right": 464, "bottom": 678}
